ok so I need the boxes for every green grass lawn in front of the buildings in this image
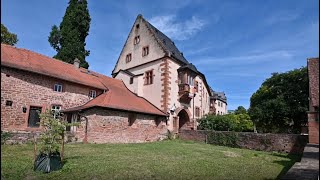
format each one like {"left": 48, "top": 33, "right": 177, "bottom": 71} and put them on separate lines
{"left": 1, "top": 140, "right": 300, "bottom": 180}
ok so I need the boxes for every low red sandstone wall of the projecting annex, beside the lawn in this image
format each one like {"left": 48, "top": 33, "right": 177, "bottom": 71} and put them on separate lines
{"left": 75, "top": 108, "right": 167, "bottom": 143}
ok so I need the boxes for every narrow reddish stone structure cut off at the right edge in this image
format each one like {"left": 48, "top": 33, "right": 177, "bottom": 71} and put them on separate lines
{"left": 307, "top": 58, "right": 319, "bottom": 144}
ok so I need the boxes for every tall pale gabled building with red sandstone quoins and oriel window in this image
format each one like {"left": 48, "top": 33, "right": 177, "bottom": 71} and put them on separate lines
{"left": 112, "top": 15, "right": 215, "bottom": 132}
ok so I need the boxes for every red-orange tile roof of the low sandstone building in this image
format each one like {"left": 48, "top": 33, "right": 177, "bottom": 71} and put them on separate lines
{"left": 1, "top": 44, "right": 166, "bottom": 116}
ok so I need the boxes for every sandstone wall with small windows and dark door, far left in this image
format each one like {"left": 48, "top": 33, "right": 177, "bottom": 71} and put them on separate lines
{"left": 1, "top": 67, "right": 102, "bottom": 131}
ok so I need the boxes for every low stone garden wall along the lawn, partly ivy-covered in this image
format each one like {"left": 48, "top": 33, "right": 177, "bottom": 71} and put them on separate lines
{"left": 179, "top": 130, "right": 308, "bottom": 154}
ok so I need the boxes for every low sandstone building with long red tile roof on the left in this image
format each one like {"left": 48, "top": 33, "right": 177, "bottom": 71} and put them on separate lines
{"left": 1, "top": 44, "right": 167, "bottom": 143}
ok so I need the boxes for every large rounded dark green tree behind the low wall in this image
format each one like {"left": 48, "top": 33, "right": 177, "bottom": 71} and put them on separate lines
{"left": 249, "top": 67, "right": 309, "bottom": 133}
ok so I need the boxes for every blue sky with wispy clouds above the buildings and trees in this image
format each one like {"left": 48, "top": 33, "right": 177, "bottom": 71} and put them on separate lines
{"left": 1, "top": 0, "right": 319, "bottom": 109}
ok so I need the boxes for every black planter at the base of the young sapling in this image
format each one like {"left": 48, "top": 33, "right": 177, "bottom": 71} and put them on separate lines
{"left": 33, "top": 152, "right": 62, "bottom": 173}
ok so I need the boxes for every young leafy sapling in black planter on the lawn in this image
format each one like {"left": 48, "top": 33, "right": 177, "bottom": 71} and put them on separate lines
{"left": 34, "top": 110, "right": 73, "bottom": 173}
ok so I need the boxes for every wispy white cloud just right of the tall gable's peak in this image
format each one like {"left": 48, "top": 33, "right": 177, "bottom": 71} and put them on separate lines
{"left": 150, "top": 15, "right": 208, "bottom": 40}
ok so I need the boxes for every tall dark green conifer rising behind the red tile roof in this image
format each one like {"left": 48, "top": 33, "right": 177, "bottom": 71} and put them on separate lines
{"left": 48, "top": 0, "right": 91, "bottom": 68}
